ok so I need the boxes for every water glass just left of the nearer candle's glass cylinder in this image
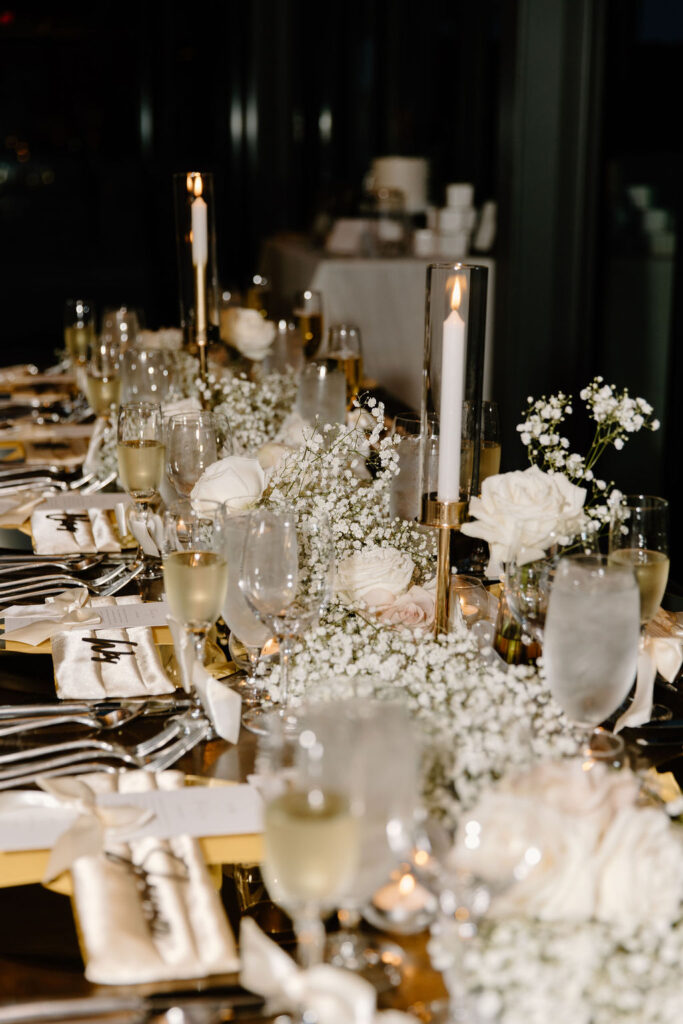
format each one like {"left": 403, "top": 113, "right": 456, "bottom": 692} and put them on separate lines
{"left": 389, "top": 413, "right": 438, "bottom": 520}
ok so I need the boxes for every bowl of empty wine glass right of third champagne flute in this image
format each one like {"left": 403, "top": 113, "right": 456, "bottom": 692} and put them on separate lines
{"left": 166, "top": 412, "right": 232, "bottom": 497}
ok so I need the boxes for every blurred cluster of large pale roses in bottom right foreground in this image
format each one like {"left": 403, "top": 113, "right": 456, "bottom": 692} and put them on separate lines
{"left": 450, "top": 758, "right": 683, "bottom": 931}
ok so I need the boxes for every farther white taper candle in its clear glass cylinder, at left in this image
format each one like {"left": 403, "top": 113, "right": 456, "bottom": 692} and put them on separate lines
{"left": 173, "top": 171, "right": 220, "bottom": 373}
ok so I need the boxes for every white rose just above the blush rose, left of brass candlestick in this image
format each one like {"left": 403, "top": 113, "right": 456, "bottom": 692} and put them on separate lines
{"left": 336, "top": 547, "right": 415, "bottom": 607}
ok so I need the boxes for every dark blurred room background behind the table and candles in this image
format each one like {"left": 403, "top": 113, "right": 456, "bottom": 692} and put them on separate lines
{"left": 0, "top": 0, "right": 683, "bottom": 574}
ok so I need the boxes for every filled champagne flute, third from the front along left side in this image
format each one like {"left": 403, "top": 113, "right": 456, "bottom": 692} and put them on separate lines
{"left": 117, "top": 401, "right": 166, "bottom": 580}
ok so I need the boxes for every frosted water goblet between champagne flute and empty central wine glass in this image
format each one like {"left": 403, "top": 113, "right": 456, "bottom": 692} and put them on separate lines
{"left": 221, "top": 499, "right": 271, "bottom": 712}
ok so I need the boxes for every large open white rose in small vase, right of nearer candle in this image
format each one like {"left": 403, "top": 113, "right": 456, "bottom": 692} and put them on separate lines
{"left": 461, "top": 466, "right": 586, "bottom": 563}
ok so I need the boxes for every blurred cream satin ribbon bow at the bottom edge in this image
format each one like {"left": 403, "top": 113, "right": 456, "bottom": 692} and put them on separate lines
{"left": 240, "top": 918, "right": 416, "bottom": 1024}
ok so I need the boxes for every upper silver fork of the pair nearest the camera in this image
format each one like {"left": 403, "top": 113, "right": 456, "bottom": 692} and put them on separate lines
{"left": 0, "top": 719, "right": 211, "bottom": 790}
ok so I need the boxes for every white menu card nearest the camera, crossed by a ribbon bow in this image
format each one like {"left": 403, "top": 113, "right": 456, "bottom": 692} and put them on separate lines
{"left": 0, "top": 779, "right": 263, "bottom": 852}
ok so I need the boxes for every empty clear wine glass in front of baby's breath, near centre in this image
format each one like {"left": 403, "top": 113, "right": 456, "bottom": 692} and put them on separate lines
{"left": 240, "top": 507, "right": 334, "bottom": 732}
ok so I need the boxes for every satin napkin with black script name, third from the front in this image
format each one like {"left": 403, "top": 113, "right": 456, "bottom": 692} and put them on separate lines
{"left": 31, "top": 508, "right": 121, "bottom": 555}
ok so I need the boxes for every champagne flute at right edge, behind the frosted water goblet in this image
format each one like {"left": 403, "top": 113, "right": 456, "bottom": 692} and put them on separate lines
{"left": 609, "top": 495, "right": 669, "bottom": 638}
